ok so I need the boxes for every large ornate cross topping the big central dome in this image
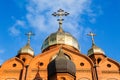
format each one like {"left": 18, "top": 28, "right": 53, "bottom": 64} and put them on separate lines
{"left": 52, "top": 9, "right": 69, "bottom": 31}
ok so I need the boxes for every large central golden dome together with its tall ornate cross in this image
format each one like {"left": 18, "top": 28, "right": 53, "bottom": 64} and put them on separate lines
{"left": 41, "top": 9, "right": 79, "bottom": 51}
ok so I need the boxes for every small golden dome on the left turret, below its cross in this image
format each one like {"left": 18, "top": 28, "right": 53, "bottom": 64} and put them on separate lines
{"left": 18, "top": 44, "right": 34, "bottom": 56}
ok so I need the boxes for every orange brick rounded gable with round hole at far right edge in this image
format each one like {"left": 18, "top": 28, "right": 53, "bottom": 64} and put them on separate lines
{"left": 99, "top": 57, "right": 120, "bottom": 80}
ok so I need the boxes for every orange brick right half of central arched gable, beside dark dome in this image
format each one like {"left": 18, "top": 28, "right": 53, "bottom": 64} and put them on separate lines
{"left": 62, "top": 47, "right": 94, "bottom": 80}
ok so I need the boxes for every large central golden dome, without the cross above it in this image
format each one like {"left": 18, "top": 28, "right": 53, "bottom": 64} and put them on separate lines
{"left": 41, "top": 27, "right": 79, "bottom": 51}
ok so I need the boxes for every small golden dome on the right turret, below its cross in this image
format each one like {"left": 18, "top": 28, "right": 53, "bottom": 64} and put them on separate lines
{"left": 88, "top": 44, "right": 105, "bottom": 56}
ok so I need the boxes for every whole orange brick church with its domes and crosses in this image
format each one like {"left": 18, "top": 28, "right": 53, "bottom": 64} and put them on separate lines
{"left": 0, "top": 9, "right": 120, "bottom": 80}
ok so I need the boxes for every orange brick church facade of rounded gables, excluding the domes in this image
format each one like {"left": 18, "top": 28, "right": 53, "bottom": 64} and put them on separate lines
{"left": 0, "top": 45, "right": 120, "bottom": 80}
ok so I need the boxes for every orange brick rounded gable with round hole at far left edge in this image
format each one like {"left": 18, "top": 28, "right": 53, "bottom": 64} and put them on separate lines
{"left": 0, "top": 57, "right": 24, "bottom": 80}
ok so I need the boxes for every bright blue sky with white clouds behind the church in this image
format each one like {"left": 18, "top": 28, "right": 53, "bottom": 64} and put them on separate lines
{"left": 0, "top": 0, "right": 120, "bottom": 64}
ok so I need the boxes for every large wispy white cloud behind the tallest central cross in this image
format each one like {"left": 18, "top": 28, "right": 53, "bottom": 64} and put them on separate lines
{"left": 26, "top": 0, "right": 95, "bottom": 36}
